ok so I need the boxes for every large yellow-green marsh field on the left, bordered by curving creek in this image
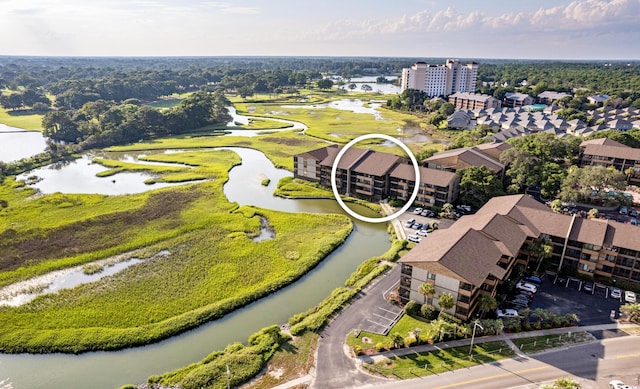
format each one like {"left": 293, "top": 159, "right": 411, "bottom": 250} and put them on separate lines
{"left": 0, "top": 150, "right": 352, "bottom": 352}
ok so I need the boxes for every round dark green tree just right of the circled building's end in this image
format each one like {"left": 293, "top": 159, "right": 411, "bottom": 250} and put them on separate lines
{"left": 458, "top": 166, "right": 504, "bottom": 208}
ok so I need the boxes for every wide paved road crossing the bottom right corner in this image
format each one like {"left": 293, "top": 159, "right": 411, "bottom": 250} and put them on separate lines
{"left": 350, "top": 336, "right": 640, "bottom": 389}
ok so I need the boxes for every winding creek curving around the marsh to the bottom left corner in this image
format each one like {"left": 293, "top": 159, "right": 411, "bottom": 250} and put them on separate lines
{"left": 0, "top": 148, "right": 390, "bottom": 389}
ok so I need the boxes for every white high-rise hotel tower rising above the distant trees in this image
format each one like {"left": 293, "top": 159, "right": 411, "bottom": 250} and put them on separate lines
{"left": 400, "top": 59, "right": 478, "bottom": 97}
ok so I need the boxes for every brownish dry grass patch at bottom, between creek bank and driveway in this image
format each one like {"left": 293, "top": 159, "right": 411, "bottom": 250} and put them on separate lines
{"left": 243, "top": 332, "right": 319, "bottom": 389}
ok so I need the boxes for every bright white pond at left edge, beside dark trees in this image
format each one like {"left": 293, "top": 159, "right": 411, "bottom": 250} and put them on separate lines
{"left": 0, "top": 124, "right": 47, "bottom": 162}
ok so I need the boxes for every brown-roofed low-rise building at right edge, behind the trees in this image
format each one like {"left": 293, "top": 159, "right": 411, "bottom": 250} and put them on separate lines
{"left": 578, "top": 138, "right": 640, "bottom": 184}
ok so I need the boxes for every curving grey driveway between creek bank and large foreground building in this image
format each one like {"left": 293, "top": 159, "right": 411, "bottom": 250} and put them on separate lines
{"left": 311, "top": 265, "right": 400, "bottom": 389}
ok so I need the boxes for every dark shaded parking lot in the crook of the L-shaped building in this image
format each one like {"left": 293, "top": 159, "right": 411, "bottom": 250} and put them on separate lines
{"left": 530, "top": 274, "right": 624, "bottom": 325}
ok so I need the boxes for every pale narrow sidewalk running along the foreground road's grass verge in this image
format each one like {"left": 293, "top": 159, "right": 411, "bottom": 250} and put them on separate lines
{"left": 356, "top": 323, "right": 637, "bottom": 364}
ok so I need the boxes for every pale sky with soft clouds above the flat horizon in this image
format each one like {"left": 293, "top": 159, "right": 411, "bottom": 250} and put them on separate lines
{"left": 0, "top": 0, "right": 640, "bottom": 60}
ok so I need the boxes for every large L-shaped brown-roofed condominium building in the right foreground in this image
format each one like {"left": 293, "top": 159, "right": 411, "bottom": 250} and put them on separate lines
{"left": 400, "top": 195, "right": 640, "bottom": 320}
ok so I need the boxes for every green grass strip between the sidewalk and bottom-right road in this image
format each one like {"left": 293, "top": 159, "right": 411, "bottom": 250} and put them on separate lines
{"left": 363, "top": 342, "right": 515, "bottom": 379}
